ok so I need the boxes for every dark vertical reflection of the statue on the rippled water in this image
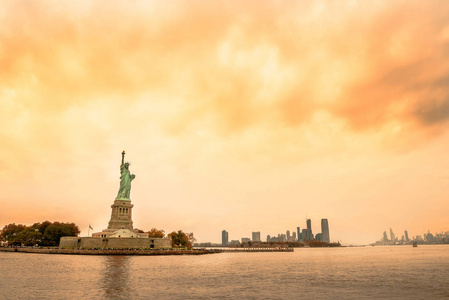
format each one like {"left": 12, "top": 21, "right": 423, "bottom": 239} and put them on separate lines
{"left": 101, "top": 255, "right": 131, "bottom": 298}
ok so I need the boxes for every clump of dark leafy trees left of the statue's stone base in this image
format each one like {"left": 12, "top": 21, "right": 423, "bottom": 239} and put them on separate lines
{"left": 0, "top": 221, "right": 80, "bottom": 247}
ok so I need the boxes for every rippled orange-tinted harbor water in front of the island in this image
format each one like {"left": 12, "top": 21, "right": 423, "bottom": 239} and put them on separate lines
{"left": 0, "top": 245, "right": 449, "bottom": 299}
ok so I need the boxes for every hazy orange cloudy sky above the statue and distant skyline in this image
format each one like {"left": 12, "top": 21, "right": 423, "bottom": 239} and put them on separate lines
{"left": 0, "top": 1, "right": 449, "bottom": 243}
